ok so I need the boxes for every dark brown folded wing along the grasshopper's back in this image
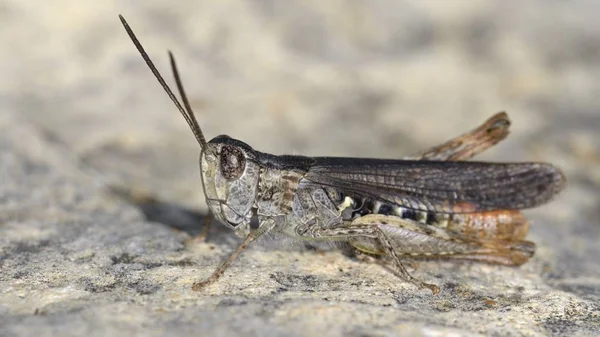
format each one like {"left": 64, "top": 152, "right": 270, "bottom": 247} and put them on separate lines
{"left": 304, "top": 157, "right": 565, "bottom": 213}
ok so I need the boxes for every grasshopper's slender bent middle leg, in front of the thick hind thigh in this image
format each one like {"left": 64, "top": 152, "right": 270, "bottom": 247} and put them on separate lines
{"left": 296, "top": 222, "right": 440, "bottom": 295}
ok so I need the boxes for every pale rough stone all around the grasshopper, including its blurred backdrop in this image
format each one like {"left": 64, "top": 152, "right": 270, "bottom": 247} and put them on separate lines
{"left": 0, "top": 0, "right": 600, "bottom": 336}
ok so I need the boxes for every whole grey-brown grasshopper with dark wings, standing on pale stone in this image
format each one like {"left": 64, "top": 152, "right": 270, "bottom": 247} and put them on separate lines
{"left": 119, "top": 15, "right": 566, "bottom": 294}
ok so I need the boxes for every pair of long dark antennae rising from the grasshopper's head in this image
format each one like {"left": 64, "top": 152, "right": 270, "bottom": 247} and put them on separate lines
{"left": 119, "top": 14, "right": 206, "bottom": 150}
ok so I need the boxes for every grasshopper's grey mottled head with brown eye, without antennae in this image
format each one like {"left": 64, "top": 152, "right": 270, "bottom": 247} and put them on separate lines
{"left": 200, "top": 136, "right": 259, "bottom": 230}
